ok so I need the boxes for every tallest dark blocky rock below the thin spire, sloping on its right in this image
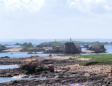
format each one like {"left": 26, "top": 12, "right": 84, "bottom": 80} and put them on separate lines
{"left": 65, "top": 42, "right": 81, "bottom": 54}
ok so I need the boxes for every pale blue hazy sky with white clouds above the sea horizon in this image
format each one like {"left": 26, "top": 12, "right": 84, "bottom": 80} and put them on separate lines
{"left": 0, "top": 0, "right": 112, "bottom": 40}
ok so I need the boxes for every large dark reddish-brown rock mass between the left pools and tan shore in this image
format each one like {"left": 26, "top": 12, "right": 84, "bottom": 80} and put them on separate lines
{"left": 20, "top": 60, "right": 54, "bottom": 74}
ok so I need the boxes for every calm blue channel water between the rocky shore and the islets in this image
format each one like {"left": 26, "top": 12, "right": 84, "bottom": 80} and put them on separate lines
{"left": 0, "top": 45, "right": 112, "bottom": 58}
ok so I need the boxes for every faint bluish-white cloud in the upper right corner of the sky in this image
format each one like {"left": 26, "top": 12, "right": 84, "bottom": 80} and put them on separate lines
{"left": 67, "top": 0, "right": 112, "bottom": 13}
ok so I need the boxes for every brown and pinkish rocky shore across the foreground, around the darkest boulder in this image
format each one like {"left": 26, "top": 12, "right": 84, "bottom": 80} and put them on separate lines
{"left": 0, "top": 56, "right": 112, "bottom": 86}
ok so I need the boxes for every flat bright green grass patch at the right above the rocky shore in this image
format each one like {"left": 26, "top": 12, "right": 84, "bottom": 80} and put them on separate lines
{"left": 60, "top": 54, "right": 112, "bottom": 65}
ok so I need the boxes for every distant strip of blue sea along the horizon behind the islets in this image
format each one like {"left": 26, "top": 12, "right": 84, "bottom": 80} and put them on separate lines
{"left": 0, "top": 38, "right": 112, "bottom": 45}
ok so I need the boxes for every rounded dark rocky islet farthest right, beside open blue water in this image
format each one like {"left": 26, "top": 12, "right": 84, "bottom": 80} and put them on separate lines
{"left": 88, "top": 44, "right": 106, "bottom": 53}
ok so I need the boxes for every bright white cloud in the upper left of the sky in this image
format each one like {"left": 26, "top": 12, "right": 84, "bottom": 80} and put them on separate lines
{"left": 0, "top": 0, "right": 45, "bottom": 12}
